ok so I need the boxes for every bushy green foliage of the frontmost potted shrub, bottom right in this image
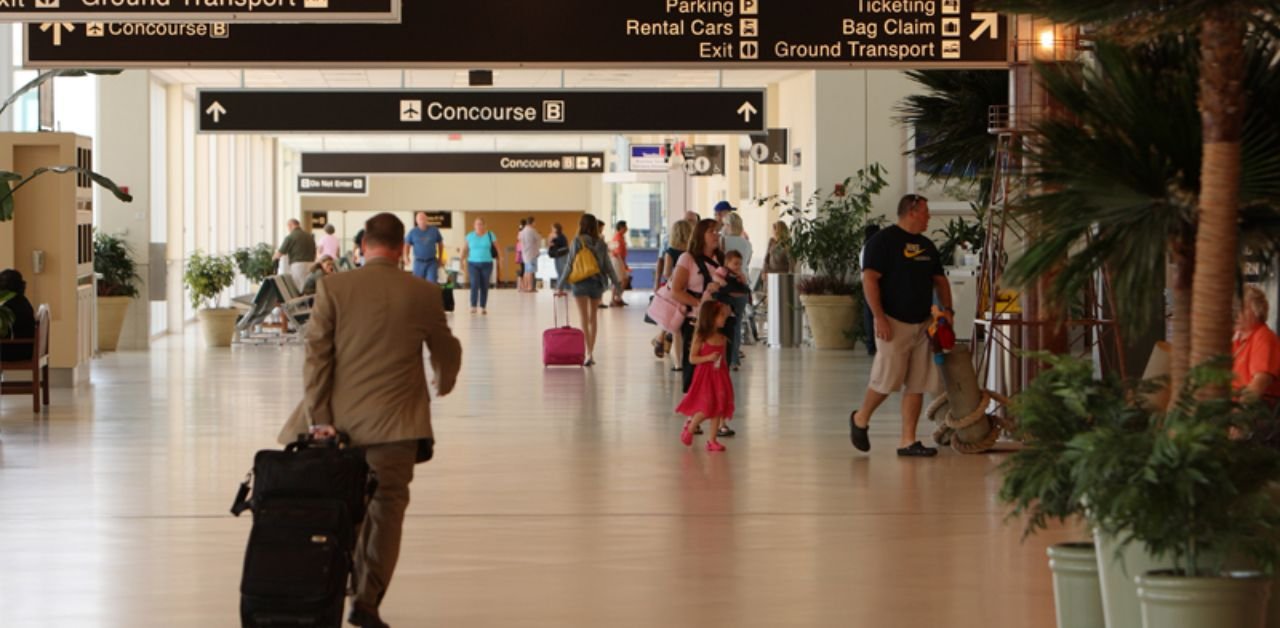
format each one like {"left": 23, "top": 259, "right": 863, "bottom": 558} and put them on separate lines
{"left": 1066, "top": 359, "right": 1280, "bottom": 577}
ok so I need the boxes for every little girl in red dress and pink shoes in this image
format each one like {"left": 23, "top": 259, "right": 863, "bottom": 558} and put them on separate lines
{"left": 676, "top": 301, "right": 733, "bottom": 451}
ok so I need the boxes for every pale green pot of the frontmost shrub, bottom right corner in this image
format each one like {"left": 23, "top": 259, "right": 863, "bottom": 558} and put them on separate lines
{"left": 1138, "top": 570, "right": 1271, "bottom": 628}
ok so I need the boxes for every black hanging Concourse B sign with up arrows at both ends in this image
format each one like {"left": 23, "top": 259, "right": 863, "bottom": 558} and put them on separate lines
{"left": 198, "top": 90, "right": 764, "bottom": 133}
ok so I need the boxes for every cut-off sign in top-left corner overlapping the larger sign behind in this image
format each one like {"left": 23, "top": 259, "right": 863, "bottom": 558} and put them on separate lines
{"left": 0, "top": 0, "right": 401, "bottom": 23}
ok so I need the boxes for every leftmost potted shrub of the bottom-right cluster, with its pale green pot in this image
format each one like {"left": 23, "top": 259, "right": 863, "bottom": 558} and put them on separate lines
{"left": 1000, "top": 353, "right": 1146, "bottom": 628}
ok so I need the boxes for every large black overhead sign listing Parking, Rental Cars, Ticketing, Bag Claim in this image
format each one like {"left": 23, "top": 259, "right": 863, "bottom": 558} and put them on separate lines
{"left": 24, "top": 0, "right": 1009, "bottom": 69}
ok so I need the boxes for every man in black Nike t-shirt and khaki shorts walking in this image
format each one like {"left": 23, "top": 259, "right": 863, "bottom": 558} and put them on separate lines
{"left": 849, "top": 194, "right": 951, "bottom": 457}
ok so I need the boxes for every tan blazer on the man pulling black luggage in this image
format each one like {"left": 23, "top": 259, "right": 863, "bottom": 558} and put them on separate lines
{"left": 279, "top": 258, "right": 462, "bottom": 446}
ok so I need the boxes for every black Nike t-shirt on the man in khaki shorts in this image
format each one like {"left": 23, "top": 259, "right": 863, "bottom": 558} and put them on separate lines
{"left": 863, "top": 225, "right": 943, "bottom": 325}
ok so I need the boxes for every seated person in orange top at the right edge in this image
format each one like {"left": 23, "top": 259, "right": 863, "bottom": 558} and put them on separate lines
{"left": 1231, "top": 285, "right": 1280, "bottom": 403}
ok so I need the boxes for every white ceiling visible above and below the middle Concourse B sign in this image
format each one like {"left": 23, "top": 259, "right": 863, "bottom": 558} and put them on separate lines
{"left": 151, "top": 68, "right": 800, "bottom": 152}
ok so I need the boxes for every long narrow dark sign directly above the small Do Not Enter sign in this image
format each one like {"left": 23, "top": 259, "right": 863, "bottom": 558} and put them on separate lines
{"left": 302, "top": 152, "right": 604, "bottom": 174}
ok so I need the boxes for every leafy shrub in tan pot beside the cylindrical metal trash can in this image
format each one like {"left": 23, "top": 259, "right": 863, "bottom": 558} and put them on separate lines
{"left": 758, "top": 164, "right": 888, "bottom": 349}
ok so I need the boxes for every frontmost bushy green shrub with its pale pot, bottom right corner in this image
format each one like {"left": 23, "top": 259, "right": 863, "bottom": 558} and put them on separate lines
{"left": 1066, "top": 365, "right": 1280, "bottom": 628}
